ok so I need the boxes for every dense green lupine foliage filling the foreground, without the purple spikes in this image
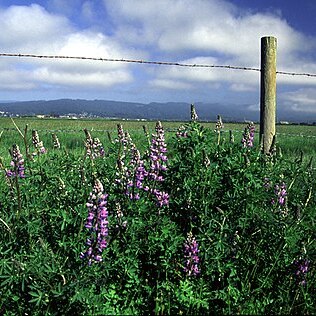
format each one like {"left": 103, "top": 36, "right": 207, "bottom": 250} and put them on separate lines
{"left": 0, "top": 118, "right": 316, "bottom": 315}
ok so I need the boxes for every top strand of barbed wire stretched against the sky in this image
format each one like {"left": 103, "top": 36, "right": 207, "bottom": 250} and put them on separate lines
{"left": 0, "top": 53, "right": 316, "bottom": 77}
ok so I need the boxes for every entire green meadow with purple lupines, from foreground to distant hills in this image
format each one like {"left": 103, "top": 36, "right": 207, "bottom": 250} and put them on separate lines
{"left": 0, "top": 108, "right": 316, "bottom": 315}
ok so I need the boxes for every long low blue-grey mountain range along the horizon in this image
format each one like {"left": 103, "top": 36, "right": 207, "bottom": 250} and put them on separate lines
{"left": 0, "top": 99, "right": 316, "bottom": 123}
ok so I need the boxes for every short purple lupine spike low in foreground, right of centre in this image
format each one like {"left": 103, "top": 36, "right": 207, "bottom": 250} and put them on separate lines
{"left": 184, "top": 232, "right": 200, "bottom": 276}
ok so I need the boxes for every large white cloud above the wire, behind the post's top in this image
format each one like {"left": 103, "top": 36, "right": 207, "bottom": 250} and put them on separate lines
{"left": 104, "top": 0, "right": 310, "bottom": 55}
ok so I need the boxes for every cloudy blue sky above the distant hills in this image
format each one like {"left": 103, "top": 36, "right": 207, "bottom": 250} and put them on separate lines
{"left": 0, "top": 0, "right": 316, "bottom": 117}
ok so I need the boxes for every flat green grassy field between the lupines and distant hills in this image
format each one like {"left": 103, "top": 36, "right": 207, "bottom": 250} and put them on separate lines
{"left": 0, "top": 117, "right": 316, "bottom": 159}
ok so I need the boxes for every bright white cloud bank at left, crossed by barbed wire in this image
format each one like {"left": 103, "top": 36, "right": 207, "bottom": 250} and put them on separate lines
{"left": 0, "top": 2, "right": 142, "bottom": 90}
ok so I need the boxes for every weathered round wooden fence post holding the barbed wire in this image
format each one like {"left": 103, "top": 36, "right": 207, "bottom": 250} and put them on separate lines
{"left": 260, "top": 36, "right": 277, "bottom": 153}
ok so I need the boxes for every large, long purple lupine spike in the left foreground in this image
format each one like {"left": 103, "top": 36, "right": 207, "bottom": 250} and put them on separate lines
{"left": 80, "top": 180, "right": 108, "bottom": 265}
